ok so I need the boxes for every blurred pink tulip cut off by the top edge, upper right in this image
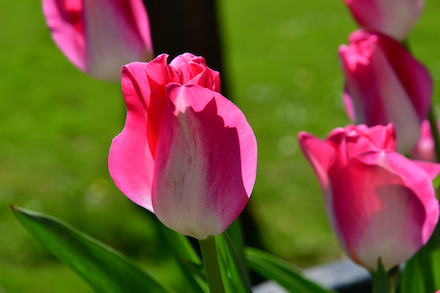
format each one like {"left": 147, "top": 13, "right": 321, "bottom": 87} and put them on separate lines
{"left": 343, "top": 0, "right": 425, "bottom": 41}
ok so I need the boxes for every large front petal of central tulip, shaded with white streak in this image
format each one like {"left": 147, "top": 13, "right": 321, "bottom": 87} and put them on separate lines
{"left": 152, "top": 84, "right": 257, "bottom": 239}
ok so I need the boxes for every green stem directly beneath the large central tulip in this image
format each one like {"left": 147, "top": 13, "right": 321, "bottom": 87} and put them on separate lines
{"left": 199, "top": 236, "right": 225, "bottom": 293}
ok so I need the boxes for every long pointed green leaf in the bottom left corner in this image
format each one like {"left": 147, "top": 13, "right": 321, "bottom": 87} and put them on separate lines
{"left": 11, "top": 206, "right": 172, "bottom": 293}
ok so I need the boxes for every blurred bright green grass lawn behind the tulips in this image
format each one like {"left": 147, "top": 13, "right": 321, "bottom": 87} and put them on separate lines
{"left": 0, "top": 0, "right": 440, "bottom": 293}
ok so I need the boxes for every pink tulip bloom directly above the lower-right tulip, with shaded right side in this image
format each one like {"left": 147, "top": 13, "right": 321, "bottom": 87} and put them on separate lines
{"left": 339, "top": 30, "right": 432, "bottom": 154}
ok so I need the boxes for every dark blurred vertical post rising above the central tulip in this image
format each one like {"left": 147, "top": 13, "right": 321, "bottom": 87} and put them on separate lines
{"left": 143, "top": 0, "right": 230, "bottom": 98}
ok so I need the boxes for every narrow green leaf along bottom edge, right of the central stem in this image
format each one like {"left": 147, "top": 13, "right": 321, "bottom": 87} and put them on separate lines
{"left": 245, "top": 247, "right": 334, "bottom": 293}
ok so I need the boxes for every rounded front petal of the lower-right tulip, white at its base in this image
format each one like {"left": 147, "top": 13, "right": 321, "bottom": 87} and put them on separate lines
{"left": 333, "top": 151, "right": 439, "bottom": 271}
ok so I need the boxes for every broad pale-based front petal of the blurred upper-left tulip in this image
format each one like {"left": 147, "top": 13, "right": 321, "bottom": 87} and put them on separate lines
{"left": 83, "top": 0, "right": 152, "bottom": 82}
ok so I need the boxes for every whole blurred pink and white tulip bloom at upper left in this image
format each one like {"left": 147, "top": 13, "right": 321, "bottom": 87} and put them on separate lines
{"left": 43, "top": 0, "right": 153, "bottom": 82}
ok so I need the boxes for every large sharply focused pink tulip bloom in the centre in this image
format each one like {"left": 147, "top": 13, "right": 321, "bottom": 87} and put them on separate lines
{"left": 109, "top": 53, "right": 257, "bottom": 239}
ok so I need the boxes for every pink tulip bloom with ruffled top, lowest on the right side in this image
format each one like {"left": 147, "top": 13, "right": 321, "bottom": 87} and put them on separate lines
{"left": 299, "top": 124, "right": 440, "bottom": 271}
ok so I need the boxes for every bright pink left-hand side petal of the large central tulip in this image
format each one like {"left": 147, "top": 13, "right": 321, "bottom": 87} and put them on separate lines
{"left": 109, "top": 62, "right": 155, "bottom": 212}
